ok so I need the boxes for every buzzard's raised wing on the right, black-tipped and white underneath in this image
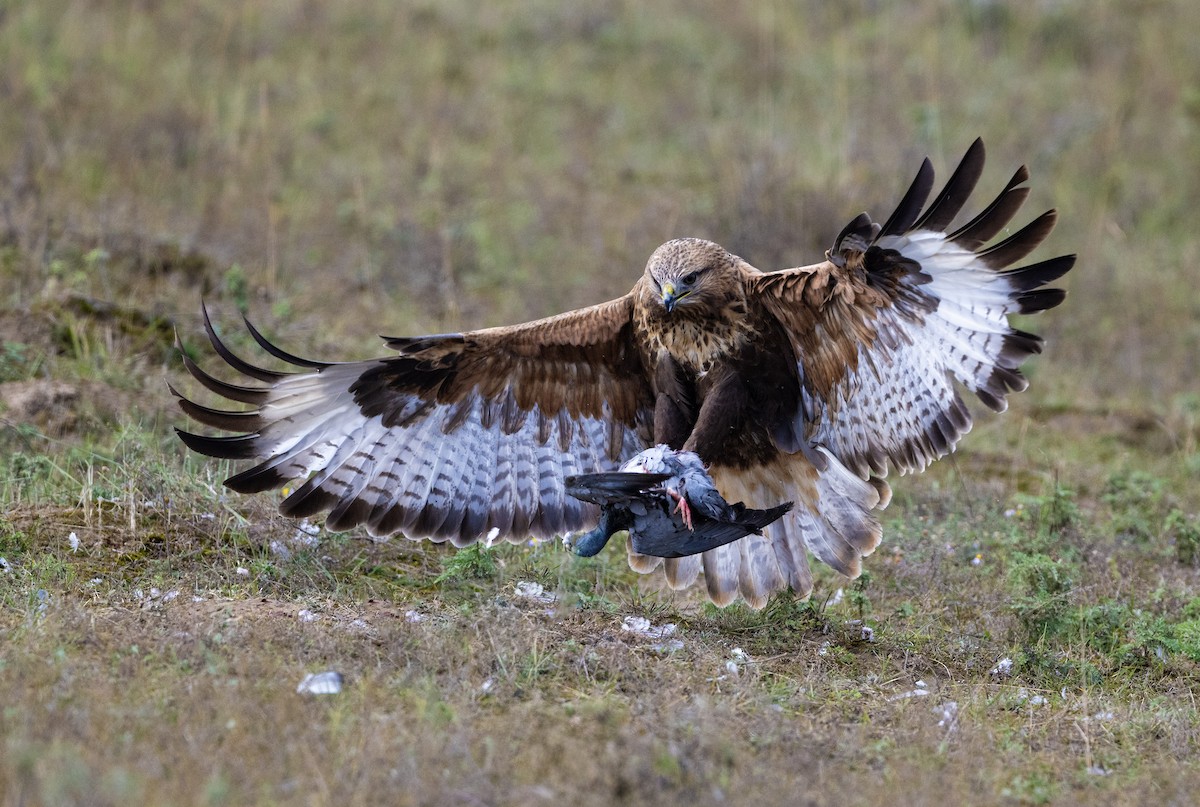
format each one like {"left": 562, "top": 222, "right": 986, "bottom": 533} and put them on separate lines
{"left": 752, "top": 141, "right": 1075, "bottom": 478}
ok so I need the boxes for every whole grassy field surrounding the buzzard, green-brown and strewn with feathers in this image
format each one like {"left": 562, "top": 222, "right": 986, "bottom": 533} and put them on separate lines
{"left": 0, "top": 0, "right": 1200, "bottom": 805}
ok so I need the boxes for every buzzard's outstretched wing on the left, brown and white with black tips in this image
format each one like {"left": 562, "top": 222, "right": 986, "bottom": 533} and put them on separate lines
{"left": 172, "top": 297, "right": 653, "bottom": 546}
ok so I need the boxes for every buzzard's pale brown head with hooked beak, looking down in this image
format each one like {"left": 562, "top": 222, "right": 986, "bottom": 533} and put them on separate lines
{"left": 646, "top": 238, "right": 737, "bottom": 313}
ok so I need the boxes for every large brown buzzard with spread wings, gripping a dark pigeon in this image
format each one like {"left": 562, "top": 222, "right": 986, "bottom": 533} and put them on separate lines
{"left": 179, "top": 141, "right": 1074, "bottom": 608}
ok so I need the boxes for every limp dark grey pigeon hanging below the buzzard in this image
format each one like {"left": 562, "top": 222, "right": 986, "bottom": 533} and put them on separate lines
{"left": 565, "top": 446, "right": 792, "bottom": 557}
